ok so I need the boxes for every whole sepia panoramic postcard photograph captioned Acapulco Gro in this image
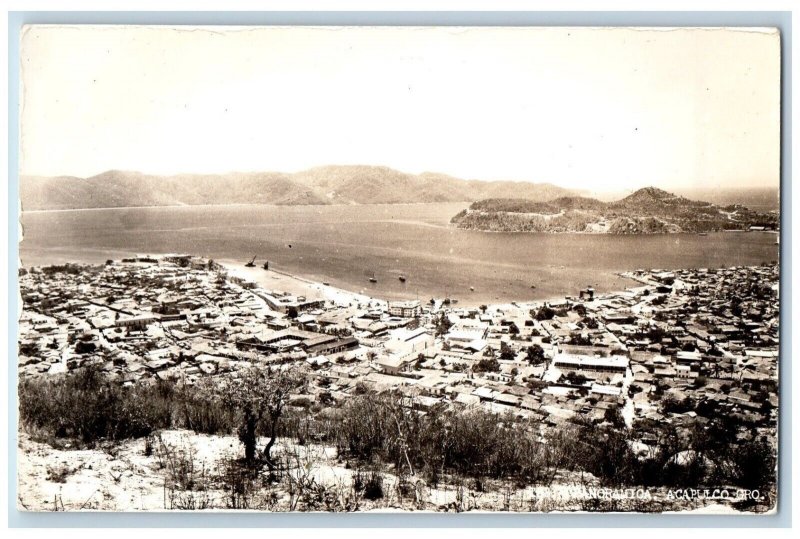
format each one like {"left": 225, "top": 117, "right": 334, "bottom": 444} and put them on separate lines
{"left": 10, "top": 24, "right": 782, "bottom": 520}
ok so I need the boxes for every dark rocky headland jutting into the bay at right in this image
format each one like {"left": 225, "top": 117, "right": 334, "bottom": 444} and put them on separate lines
{"left": 451, "top": 187, "right": 778, "bottom": 234}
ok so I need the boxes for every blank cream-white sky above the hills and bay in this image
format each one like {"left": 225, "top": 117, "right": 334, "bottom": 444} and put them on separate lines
{"left": 21, "top": 26, "right": 780, "bottom": 191}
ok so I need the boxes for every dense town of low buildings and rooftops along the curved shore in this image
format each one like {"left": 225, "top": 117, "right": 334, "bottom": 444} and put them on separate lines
{"left": 19, "top": 255, "right": 779, "bottom": 450}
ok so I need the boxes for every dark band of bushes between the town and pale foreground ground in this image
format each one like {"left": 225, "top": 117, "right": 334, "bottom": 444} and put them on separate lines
{"left": 19, "top": 368, "right": 775, "bottom": 504}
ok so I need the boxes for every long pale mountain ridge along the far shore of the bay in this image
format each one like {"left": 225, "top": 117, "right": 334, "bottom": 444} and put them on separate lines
{"left": 20, "top": 165, "right": 576, "bottom": 210}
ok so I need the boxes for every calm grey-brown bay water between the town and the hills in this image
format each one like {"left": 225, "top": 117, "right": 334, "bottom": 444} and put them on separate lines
{"left": 20, "top": 203, "right": 778, "bottom": 304}
